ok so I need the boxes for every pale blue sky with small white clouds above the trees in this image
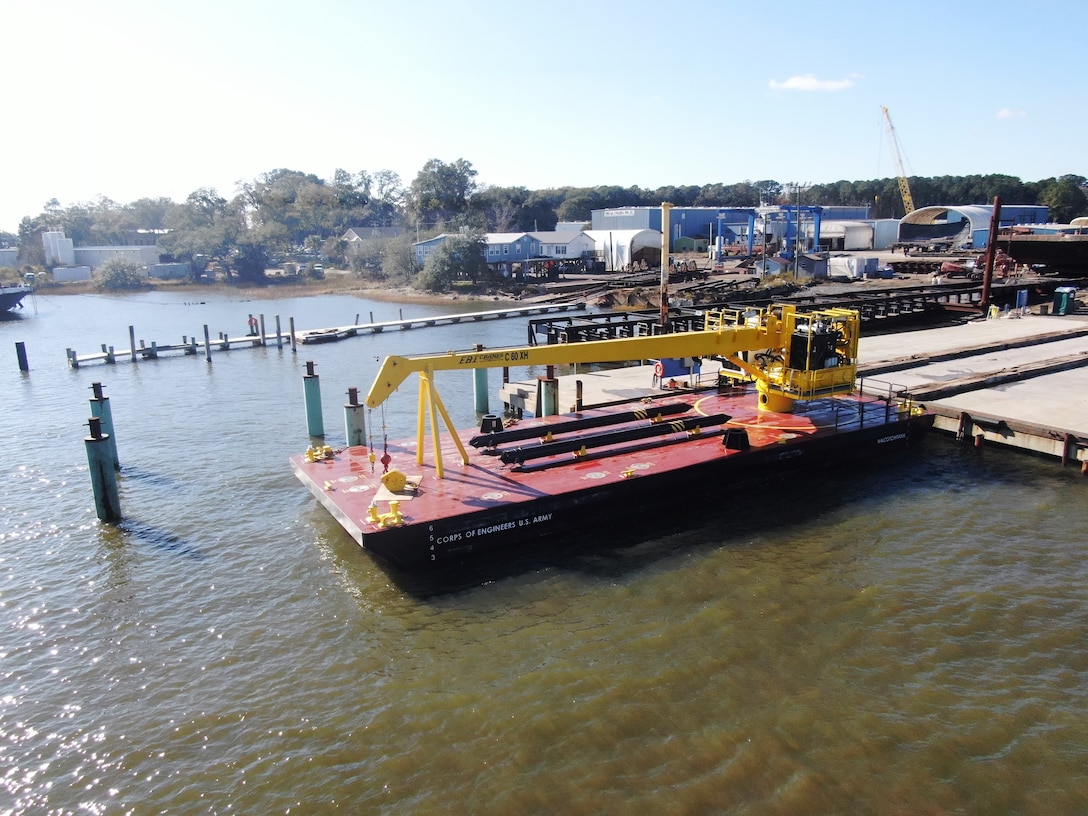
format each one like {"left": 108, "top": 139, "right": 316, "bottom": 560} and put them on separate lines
{"left": 0, "top": 0, "right": 1088, "bottom": 231}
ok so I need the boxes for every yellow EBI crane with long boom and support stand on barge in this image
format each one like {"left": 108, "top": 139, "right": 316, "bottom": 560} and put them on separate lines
{"left": 366, "top": 305, "right": 861, "bottom": 478}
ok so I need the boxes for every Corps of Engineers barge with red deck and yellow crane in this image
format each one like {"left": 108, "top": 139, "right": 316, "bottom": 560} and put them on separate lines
{"left": 292, "top": 306, "right": 932, "bottom": 569}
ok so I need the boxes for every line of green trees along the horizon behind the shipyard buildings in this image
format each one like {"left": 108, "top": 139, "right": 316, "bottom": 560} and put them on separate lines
{"left": 0, "top": 159, "right": 1088, "bottom": 283}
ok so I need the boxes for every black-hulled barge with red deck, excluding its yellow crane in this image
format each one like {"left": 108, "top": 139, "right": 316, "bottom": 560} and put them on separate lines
{"left": 292, "top": 388, "right": 932, "bottom": 567}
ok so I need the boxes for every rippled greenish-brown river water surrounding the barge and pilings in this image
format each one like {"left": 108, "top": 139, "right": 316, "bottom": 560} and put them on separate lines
{"left": 0, "top": 296, "right": 1088, "bottom": 816}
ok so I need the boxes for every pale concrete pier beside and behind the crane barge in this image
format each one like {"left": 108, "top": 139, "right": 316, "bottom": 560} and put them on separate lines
{"left": 500, "top": 313, "right": 1088, "bottom": 470}
